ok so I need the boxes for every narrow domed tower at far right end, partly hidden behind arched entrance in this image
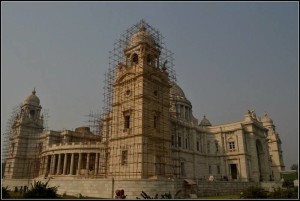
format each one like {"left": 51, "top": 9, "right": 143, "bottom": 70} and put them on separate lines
{"left": 261, "top": 114, "right": 285, "bottom": 181}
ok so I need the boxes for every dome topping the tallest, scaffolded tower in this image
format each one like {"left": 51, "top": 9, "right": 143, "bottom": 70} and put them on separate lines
{"left": 129, "top": 24, "right": 156, "bottom": 47}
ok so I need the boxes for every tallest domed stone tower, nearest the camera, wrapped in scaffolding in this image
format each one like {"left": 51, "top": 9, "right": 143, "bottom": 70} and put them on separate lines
{"left": 109, "top": 21, "right": 172, "bottom": 178}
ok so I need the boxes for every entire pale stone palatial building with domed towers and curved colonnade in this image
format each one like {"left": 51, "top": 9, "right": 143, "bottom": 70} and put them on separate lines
{"left": 4, "top": 21, "right": 284, "bottom": 186}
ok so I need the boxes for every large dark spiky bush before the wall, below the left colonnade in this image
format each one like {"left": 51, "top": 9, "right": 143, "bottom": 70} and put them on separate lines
{"left": 24, "top": 180, "right": 58, "bottom": 198}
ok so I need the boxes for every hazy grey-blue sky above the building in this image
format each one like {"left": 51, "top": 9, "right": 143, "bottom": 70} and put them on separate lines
{"left": 1, "top": 2, "right": 299, "bottom": 169}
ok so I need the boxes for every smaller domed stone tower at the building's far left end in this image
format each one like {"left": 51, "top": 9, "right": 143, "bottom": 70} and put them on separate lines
{"left": 4, "top": 89, "right": 43, "bottom": 179}
